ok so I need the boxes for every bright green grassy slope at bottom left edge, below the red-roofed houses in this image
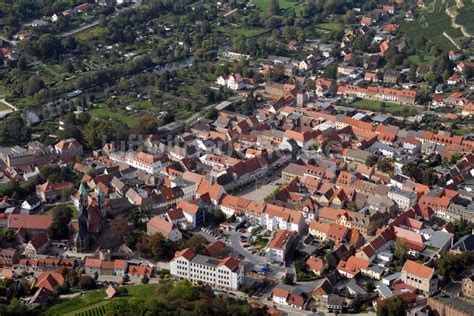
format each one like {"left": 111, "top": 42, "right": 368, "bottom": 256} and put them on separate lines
{"left": 41, "top": 284, "right": 156, "bottom": 316}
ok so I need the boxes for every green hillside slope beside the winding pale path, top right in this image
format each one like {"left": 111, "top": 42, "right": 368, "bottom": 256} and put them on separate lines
{"left": 400, "top": 0, "right": 462, "bottom": 50}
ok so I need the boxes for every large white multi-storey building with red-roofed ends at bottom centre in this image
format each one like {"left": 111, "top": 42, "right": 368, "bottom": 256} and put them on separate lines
{"left": 170, "top": 248, "right": 244, "bottom": 290}
